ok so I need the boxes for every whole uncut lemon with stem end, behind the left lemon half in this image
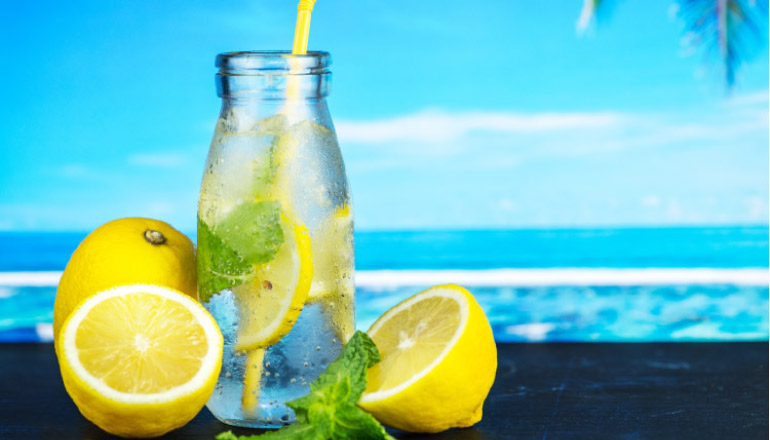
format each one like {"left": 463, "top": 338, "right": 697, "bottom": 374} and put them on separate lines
{"left": 53, "top": 218, "right": 198, "bottom": 342}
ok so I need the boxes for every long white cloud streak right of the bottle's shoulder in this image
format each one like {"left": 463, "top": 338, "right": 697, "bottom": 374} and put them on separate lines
{"left": 335, "top": 110, "right": 627, "bottom": 144}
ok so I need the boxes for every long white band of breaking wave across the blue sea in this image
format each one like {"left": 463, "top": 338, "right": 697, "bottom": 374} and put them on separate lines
{"left": 0, "top": 268, "right": 770, "bottom": 288}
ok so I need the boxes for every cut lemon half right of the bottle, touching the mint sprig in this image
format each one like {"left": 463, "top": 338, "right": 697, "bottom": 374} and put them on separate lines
{"left": 358, "top": 284, "right": 497, "bottom": 432}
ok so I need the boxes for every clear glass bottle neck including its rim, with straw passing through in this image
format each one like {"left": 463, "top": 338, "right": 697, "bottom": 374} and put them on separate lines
{"left": 216, "top": 52, "right": 331, "bottom": 102}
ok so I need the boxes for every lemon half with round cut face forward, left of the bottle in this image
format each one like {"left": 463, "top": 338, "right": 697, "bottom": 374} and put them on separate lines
{"left": 57, "top": 284, "right": 222, "bottom": 437}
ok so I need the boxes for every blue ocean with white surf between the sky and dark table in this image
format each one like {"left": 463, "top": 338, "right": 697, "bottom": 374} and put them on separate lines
{"left": 0, "top": 226, "right": 769, "bottom": 342}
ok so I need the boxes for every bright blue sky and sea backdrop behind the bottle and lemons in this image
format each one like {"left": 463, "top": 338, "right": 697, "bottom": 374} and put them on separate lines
{"left": 0, "top": 0, "right": 769, "bottom": 342}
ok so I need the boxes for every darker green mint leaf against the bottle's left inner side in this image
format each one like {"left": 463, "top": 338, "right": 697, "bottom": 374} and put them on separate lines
{"left": 197, "top": 218, "right": 254, "bottom": 302}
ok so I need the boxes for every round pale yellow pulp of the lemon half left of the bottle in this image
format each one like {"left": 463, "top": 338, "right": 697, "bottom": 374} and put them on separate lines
{"left": 75, "top": 293, "right": 209, "bottom": 394}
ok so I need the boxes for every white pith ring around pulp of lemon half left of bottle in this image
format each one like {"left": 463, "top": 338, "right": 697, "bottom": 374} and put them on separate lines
{"left": 59, "top": 284, "right": 223, "bottom": 404}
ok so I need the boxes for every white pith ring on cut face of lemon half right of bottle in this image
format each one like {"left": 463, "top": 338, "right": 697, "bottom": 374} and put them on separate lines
{"left": 359, "top": 284, "right": 470, "bottom": 403}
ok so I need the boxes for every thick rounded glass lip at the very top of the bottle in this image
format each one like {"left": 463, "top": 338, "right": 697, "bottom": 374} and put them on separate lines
{"left": 215, "top": 50, "right": 331, "bottom": 76}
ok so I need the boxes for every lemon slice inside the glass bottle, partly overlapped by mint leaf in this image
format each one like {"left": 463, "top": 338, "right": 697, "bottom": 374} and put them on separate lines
{"left": 233, "top": 215, "right": 313, "bottom": 350}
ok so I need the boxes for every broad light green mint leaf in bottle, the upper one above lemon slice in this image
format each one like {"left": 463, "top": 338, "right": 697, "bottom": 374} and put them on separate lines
{"left": 214, "top": 201, "right": 284, "bottom": 264}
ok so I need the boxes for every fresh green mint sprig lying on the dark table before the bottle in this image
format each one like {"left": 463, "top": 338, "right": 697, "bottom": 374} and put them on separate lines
{"left": 216, "top": 331, "right": 393, "bottom": 440}
